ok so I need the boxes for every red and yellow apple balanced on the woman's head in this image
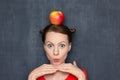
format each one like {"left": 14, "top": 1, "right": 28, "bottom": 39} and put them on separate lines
{"left": 49, "top": 10, "right": 64, "bottom": 25}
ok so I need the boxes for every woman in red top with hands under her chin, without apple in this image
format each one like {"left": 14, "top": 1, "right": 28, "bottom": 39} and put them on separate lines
{"left": 28, "top": 24, "right": 87, "bottom": 80}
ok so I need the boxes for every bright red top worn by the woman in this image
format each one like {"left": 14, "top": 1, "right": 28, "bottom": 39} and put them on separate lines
{"left": 36, "top": 68, "right": 88, "bottom": 80}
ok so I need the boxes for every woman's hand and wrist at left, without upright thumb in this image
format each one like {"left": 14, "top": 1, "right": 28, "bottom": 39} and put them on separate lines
{"left": 28, "top": 64, "right": 57, "bottom": 80}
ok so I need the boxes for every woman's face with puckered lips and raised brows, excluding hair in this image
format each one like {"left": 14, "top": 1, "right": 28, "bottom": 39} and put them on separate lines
{"left": 44, "top": 32, "right": 71, "bottom": 65}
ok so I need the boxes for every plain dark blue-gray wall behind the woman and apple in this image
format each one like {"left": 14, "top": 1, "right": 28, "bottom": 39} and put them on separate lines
{"left": 0, "top": 0, "right": 120, "bottom": 80}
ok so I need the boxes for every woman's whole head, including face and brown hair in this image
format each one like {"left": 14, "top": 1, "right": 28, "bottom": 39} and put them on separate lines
{"left": 39, "top": 25, "right": 74, "bottom": 65}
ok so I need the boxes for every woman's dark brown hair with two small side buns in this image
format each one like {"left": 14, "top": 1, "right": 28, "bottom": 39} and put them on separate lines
{"left": 40, "top": 24, "right": 76, "bottom": 43}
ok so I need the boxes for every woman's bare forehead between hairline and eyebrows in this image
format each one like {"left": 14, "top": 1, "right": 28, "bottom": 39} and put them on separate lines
{"left": 45, "top": 32, "right": 68, "bottom": 43}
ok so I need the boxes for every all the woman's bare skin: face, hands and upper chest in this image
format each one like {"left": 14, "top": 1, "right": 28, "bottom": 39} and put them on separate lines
{"left": 28, "top": 32, "right": 86, "bottom": 80}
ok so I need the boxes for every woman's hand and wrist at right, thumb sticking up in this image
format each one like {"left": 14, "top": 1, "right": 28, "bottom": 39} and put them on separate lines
{"left": 57, "top": 61, "right": 86, "bottom": 80}
